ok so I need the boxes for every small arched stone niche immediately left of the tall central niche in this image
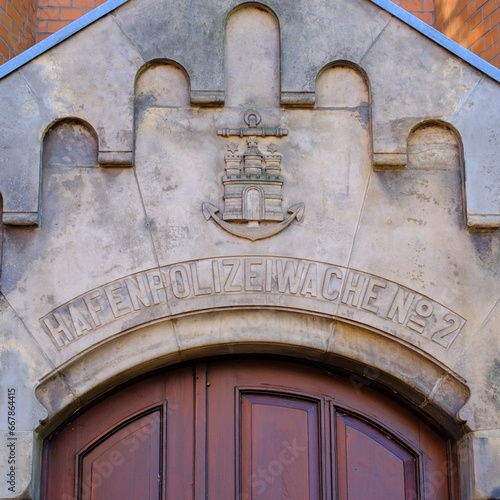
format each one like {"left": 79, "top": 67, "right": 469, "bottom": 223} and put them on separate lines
{"left": 135, "top": 59, "right": 190, "bottom": 107}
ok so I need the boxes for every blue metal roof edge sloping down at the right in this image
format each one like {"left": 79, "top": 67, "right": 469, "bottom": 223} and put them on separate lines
{"left": 370, "top": 0, "right": 500, "bottom": 83}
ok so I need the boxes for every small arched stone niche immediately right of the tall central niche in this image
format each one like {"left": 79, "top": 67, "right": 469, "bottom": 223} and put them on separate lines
{"left": 315, "top": 61, "right": 371, "bottom": 112}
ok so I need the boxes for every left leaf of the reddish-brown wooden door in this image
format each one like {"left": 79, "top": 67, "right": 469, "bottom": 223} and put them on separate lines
{"left": 41, "top": 367, "right": 194, "bottom": 500}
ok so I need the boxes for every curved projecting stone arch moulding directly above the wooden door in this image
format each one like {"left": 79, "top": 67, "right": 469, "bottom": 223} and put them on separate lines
{"left": 36, "top": 309, "right": 469, "bottom": 438}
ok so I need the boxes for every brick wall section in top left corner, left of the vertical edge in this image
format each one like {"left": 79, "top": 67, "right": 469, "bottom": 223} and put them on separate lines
{"left": 0, "top": 0, "right": 36, "bottom": 64}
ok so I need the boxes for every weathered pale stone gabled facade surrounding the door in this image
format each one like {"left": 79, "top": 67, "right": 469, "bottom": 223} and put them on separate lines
{"left": 0, "top": 0, "right": 500, "bottom": 500}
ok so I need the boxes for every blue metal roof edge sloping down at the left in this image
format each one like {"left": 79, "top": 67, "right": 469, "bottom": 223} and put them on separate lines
{"left": 0, "top": 0, "right": 128, "bottom": 79}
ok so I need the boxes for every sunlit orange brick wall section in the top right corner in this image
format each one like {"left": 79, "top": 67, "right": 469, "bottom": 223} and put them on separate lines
{"left": 435, "top": 0, "right": 500, "bottom": 68}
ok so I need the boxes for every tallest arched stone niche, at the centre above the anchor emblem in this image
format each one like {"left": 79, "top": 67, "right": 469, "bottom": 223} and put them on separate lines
{"left": 224, "top": 2, "right": 280, "bottom": 106}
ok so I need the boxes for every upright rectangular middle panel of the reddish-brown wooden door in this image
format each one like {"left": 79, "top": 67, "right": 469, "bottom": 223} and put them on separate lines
{"left": 239, "top": 393, "right": 322, "bottom": 500}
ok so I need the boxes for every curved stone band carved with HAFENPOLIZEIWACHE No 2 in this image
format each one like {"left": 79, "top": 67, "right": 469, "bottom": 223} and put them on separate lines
{"left": 40, "top": 256, "right": 465, "bottom": 349}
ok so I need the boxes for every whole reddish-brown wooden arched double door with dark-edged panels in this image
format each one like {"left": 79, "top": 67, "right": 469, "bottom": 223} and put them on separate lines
{"left": 42, "top": 359, "right": 456, "bottom": 500}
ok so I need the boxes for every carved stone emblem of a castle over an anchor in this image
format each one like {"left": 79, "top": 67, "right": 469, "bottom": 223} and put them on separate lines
{"left": 202, "top": 110, "right": 305, "bottom": 241}
